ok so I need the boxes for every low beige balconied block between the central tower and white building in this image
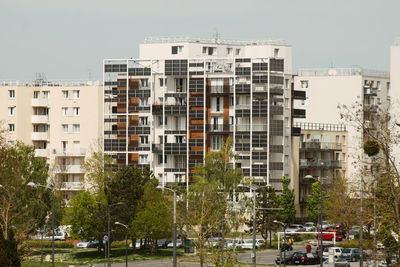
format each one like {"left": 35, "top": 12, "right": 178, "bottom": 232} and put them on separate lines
{"left": 293, "top": 122, "right": 348, "bottom": 218}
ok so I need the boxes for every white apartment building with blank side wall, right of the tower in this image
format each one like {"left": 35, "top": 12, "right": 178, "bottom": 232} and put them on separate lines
{"left": 294, "top": 68, "right": 390, "bottom": 186}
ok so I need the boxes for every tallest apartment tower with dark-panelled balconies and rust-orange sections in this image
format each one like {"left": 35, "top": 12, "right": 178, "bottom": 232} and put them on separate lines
{"left": 103, "top": 38, "right": 305, "bottom": 190}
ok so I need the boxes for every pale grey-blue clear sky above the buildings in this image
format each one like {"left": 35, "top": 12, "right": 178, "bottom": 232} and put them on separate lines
{"left": 0, "top": 0, "right": 400, "bottom": 80}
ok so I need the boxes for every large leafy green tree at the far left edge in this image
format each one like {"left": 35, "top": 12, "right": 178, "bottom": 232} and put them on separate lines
{"left": 0, "top": 142, "right": 51, "bottom": 262}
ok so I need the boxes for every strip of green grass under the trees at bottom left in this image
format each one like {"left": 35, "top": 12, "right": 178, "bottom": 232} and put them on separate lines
{"left": 22, "top": 247, "right": 188, "bottom": 267}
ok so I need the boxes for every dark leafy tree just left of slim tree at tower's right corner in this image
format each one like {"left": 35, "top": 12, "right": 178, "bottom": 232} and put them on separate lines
{"left": 246, "top": 187, "right": 280, "bottom": 246}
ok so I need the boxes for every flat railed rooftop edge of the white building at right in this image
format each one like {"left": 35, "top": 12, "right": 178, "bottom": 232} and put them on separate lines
{"left": 299, "top": 67, "right": 390, "bottom": 78}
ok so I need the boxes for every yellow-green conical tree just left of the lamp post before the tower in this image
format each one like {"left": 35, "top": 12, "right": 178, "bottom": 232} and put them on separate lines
{"left": 131, "top": 179, "right": 173, "bottom": 253}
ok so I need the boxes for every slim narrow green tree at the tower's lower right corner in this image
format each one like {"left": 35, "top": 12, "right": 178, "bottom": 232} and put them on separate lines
{"left": 279, "top": 177, "right": 296, "bottom": 224}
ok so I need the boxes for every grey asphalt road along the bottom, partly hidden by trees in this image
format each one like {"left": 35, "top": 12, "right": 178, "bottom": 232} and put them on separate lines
{"left": 74, "top": 246, "right": 359, "bottom": 267}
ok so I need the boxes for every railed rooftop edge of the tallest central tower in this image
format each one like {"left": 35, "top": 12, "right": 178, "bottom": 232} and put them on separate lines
{"left": 144, "top": 36, "right": 289, "bottom": 46}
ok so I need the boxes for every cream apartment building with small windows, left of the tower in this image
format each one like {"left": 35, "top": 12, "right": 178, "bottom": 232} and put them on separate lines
{"left": 0, "top": 78, "right": 103, "bottom": 200}
